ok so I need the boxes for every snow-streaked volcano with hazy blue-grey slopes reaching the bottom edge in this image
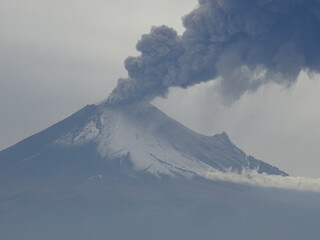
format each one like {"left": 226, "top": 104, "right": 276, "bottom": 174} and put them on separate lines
{"left": 0, "top": 102, "right": 320, "bottom": 240}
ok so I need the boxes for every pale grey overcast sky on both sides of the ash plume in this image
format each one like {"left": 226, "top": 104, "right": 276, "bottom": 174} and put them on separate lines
{"left": 0, "top": 0, "right": 320, "bottom": 177}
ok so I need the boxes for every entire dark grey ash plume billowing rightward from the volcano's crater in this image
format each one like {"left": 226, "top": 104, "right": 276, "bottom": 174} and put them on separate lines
{"left": 109, "top": 0, "right": 320, "bottom": 103}
